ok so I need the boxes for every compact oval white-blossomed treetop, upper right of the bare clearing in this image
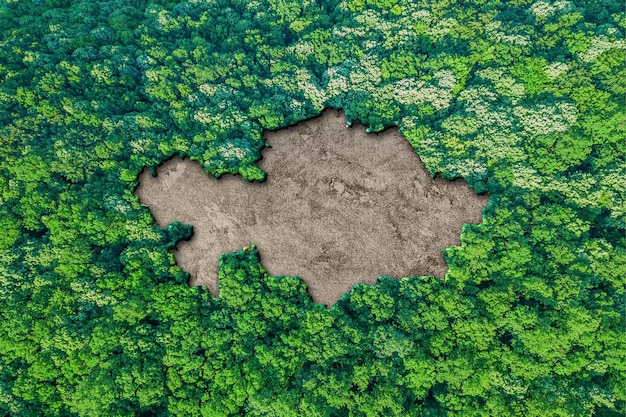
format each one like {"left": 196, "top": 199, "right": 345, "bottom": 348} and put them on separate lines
{"left": 513, "top": 102, "right": 578, "bottom": 135}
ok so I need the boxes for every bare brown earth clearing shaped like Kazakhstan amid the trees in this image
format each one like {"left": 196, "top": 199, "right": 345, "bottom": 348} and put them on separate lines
{"left": 136, "top": 110, "right": 488, "bottom": 306}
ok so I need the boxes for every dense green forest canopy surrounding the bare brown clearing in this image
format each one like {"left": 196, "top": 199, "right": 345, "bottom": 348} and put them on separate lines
{"left": 0, "top": 0, "right": 626, "bottom": 417}
